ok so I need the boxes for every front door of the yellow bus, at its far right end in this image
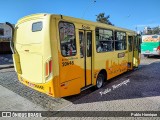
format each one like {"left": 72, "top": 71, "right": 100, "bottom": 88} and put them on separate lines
{"left": 133, "top": 36, "right": 140, "bottom": 67}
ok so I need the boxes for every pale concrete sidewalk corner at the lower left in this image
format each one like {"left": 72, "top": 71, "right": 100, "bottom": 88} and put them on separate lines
{"left": 0, "top": 85, "right": 45, "bottom": 111}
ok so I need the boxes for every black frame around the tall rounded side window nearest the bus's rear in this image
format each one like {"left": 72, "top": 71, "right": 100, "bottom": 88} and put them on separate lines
{"left": 58, "top": 21, "right": 77, "bottom": 57}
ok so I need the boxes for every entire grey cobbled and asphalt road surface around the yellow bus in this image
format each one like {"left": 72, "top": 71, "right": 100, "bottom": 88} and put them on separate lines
{"left": 0, "top": 54, "right": 160, "bottom": 119}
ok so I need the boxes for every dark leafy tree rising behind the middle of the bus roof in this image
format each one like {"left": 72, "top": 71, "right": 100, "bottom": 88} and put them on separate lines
{"left": 96, "top": 13, "right": 113, "bottom": 25}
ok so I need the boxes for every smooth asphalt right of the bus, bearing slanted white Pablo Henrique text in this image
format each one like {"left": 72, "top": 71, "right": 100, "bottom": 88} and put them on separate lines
{"left": 62, "top": 60, "right": 160, "bottom": 111}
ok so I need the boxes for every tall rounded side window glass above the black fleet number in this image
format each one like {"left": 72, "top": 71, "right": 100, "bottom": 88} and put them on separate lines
{"left": 59, "top": 22, "right": 77, "bottom": 57}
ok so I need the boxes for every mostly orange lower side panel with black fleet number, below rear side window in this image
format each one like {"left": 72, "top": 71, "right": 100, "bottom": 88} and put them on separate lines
{"left": 59, "top": 54, "right": 84, "bottom": 96}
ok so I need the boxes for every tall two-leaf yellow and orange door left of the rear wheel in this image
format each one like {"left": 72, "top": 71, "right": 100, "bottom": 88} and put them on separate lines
{"left": 79, "top": 30, "right": 92, "bottom": 88}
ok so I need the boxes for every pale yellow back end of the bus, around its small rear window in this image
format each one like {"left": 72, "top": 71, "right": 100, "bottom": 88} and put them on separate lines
{"left": 13, "top": 14, "right": 59, "bottom": 96}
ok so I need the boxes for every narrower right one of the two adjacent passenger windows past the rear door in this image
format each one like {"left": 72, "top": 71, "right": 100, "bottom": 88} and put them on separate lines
{"left": 115, "top": 32, "right": 126, "bottom": 50}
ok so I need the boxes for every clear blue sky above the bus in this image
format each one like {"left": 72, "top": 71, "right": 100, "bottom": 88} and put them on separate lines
{"left": 0, "top": 0, "right": 160, "bottom": 31}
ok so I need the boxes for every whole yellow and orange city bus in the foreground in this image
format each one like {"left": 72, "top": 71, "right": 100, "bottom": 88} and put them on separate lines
{"left": 8, "top": 14, "right": 140, "bottom": 97}
